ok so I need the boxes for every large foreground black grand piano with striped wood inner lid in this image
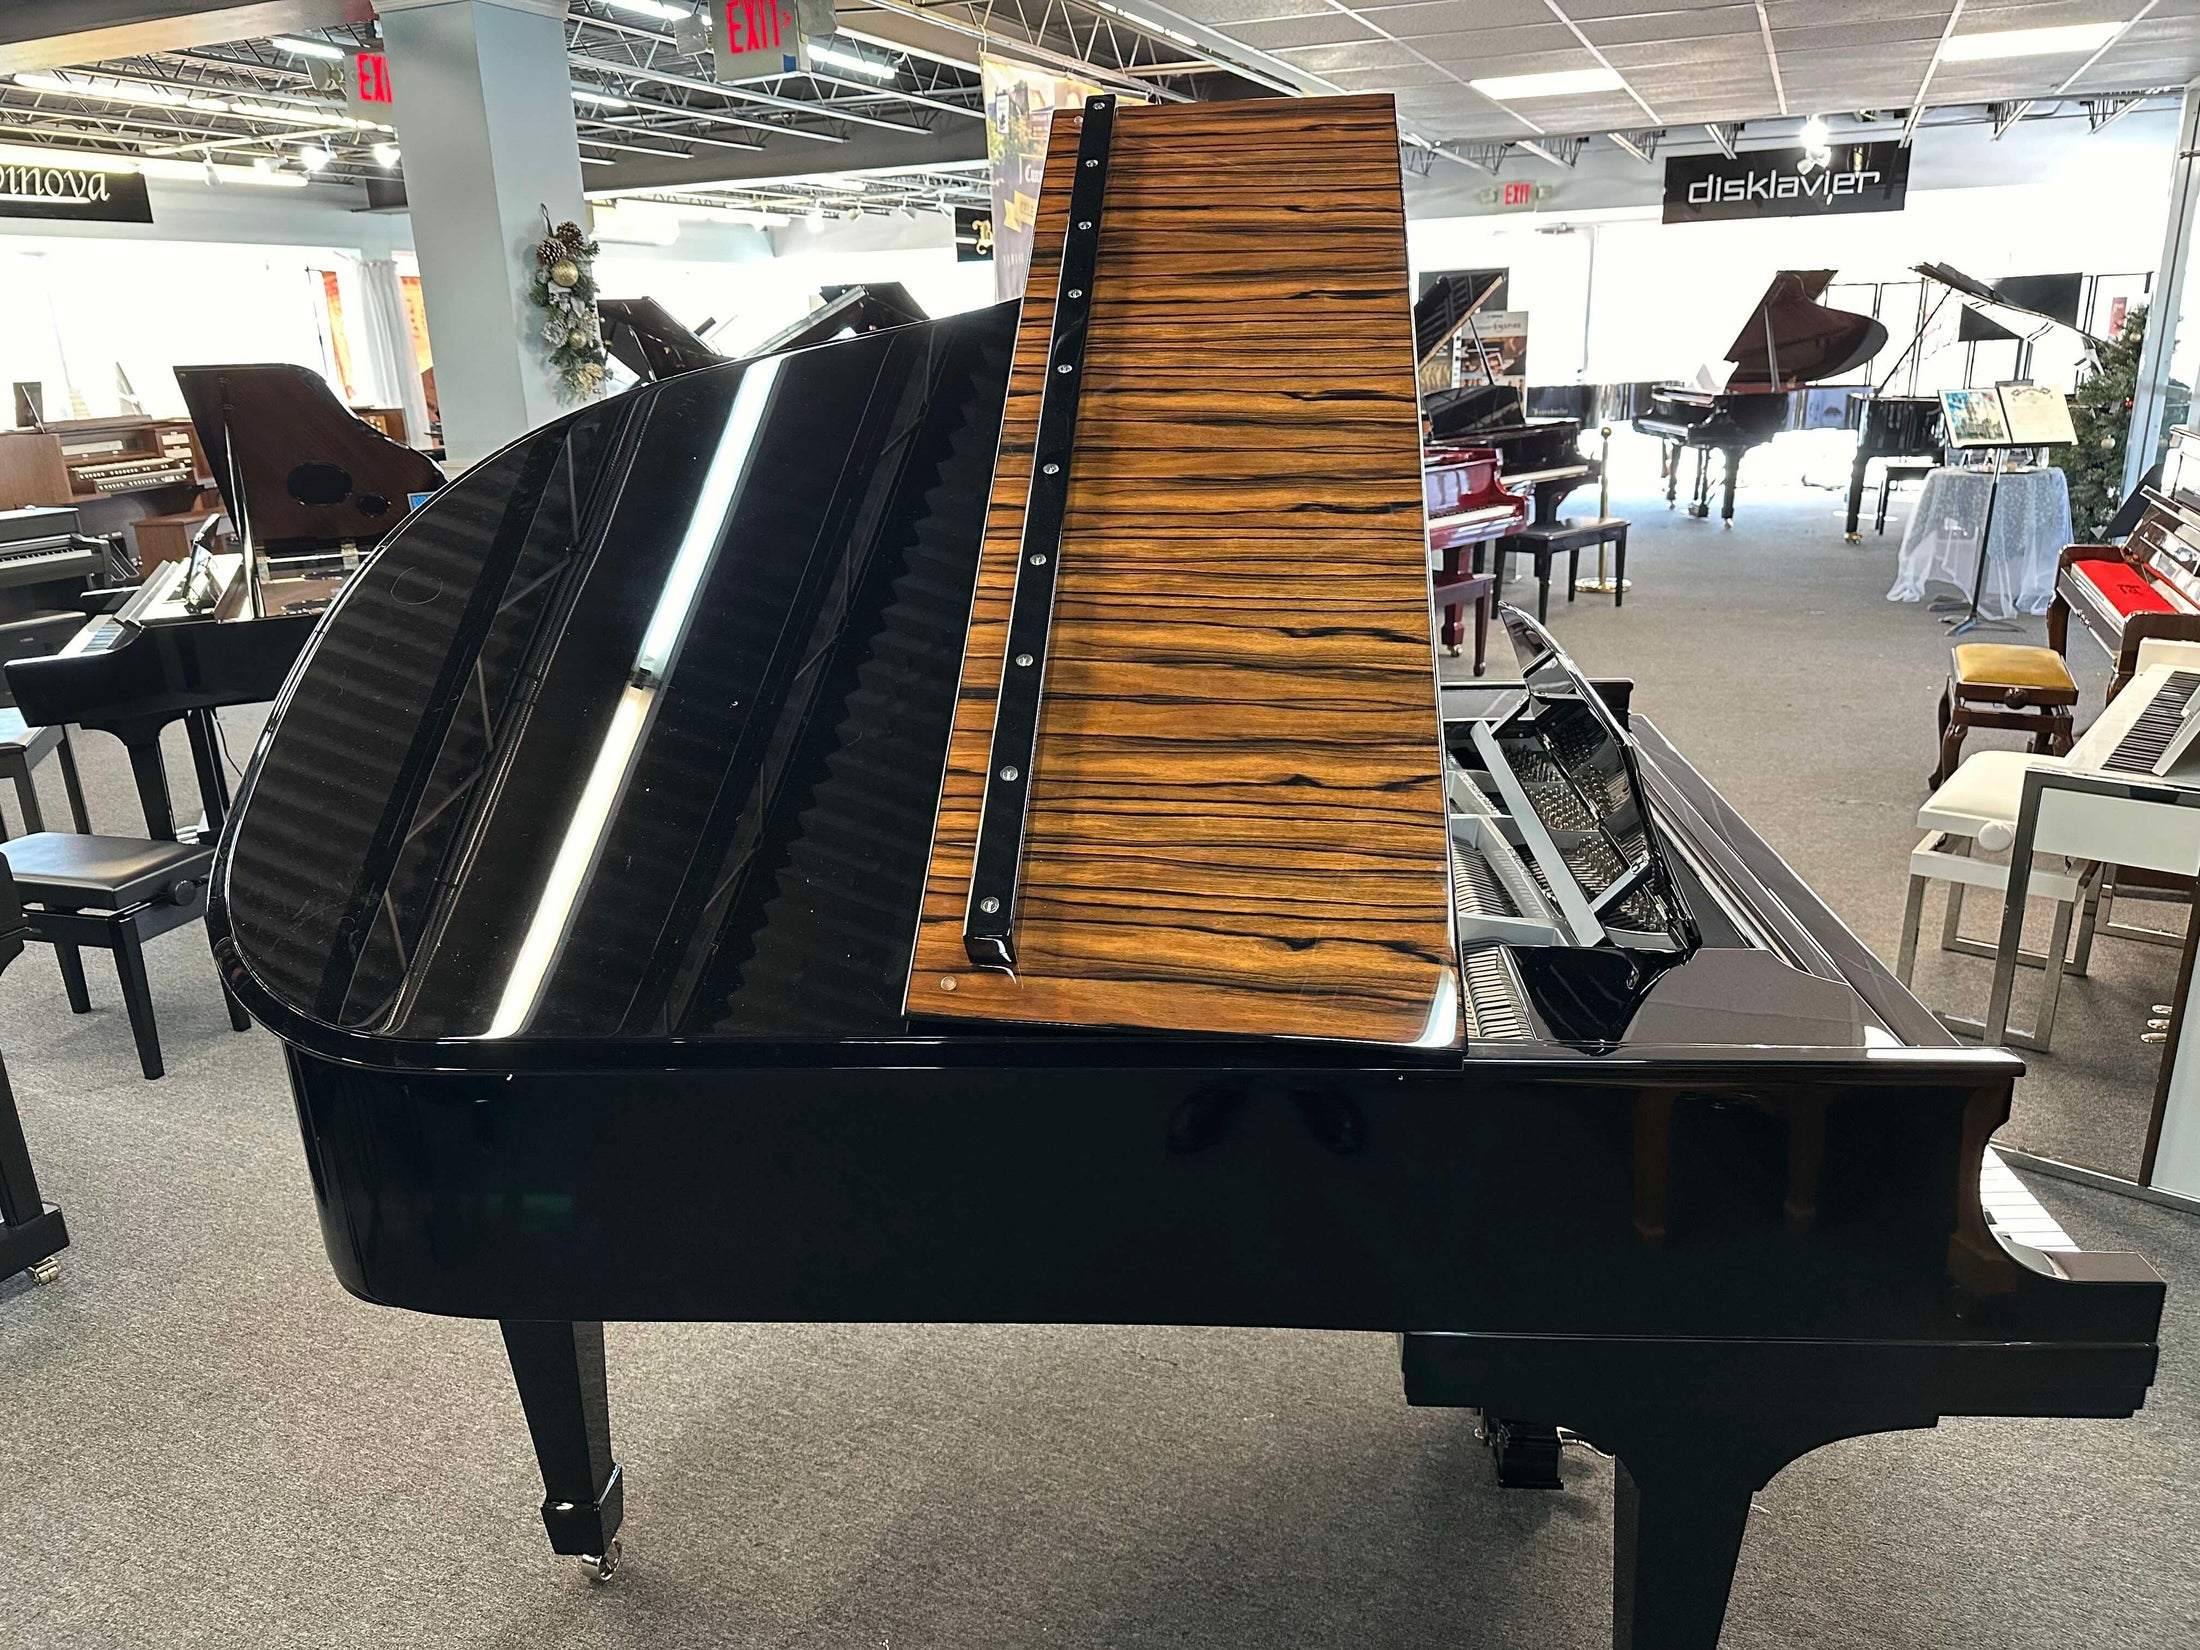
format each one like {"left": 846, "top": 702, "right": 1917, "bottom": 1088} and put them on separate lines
{"left": 209, "top": 97, "right": 2163, "bottom": 1650}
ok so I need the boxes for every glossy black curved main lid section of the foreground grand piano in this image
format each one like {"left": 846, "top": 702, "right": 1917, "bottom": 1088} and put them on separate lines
{"left": 213, "top": 306, "right": 1016, "bottom": 1058}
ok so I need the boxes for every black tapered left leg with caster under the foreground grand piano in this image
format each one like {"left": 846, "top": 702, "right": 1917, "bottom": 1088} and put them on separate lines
{"left": 504, "top": 1320, "right": 625, "bottom": 1580}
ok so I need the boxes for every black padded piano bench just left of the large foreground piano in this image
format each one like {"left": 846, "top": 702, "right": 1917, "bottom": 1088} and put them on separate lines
{"left": 0, "top": 832, "right": 251, "bottom": 1078}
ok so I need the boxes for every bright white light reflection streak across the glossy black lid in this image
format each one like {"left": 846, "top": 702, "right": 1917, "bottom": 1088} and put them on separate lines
{"left": 482, "top": 356, "right": 785, "bottom": 1038}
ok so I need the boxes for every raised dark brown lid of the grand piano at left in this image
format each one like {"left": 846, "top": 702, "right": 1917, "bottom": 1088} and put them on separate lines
{"left": 176, "top": 363, "right": 442, "bottom": 550}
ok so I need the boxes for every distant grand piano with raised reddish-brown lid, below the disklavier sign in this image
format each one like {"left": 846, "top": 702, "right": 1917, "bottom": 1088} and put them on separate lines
{"left": 1635, "top": 268, "right": 1888, "bottom": 526}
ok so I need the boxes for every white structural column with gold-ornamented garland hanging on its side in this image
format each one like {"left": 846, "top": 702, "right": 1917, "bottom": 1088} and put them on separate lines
{"left": 376, "top": 0, "right": 587, "bottom": 469}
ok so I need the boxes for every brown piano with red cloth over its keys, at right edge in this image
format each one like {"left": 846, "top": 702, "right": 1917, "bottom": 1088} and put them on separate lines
{"left": 2048, "top": 425, "right": 2200, "bottom": 697}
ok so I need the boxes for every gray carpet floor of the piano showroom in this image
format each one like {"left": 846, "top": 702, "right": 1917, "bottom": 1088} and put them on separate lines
{"left": 0, "top": 470, "right": 2200, "bottom": 1650}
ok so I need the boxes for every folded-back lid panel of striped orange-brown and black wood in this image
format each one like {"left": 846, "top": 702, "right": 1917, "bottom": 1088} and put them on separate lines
{"left": 909, "top": 97, "right": 1459, "bottom": 1043}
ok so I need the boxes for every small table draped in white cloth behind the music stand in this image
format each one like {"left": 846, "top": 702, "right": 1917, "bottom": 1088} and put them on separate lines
{"left": 1888, "top": 466, "right": 2070, "bottom": 618}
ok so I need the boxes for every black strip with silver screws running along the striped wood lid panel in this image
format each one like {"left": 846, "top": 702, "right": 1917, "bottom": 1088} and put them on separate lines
{"left": 964, "top": 95, "right": 1115, "bottom": 968}
